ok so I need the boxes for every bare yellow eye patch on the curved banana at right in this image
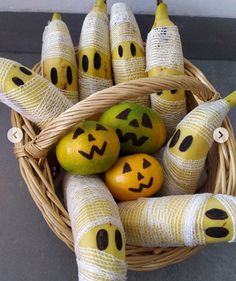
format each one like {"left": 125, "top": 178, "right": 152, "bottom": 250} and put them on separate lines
{"left": 168, "top": 128, "right": 209, "bottom": 160}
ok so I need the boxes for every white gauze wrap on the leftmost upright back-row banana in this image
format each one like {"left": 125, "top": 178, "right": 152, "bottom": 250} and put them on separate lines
{"left": 41, "top": 20, "right": 79, "bottom": 103}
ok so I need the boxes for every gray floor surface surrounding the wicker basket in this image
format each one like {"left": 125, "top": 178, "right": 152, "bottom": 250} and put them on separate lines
{"left": 0, "top": 53, "right": 236, "bottom": 281}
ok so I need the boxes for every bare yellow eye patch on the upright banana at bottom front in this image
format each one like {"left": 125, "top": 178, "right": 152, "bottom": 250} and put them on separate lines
{"left": 79, "top": 224, "right": 125, "bottom": 259}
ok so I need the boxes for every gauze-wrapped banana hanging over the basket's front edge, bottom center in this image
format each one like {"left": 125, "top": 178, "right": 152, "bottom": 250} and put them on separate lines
{"left": 64, "top": 174, "right": 127, "bottom": 281}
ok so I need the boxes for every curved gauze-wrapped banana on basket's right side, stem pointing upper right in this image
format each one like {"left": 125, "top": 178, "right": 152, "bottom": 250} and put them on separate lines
{"left": 161, "top": 91, "right": 236, "bottom": 195}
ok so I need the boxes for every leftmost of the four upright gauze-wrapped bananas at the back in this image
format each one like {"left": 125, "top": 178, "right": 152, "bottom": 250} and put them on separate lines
{"left": 41, "top": 13, "right": 79, "bottom": 103}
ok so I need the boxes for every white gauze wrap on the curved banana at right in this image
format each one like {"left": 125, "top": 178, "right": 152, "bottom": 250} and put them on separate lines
{"left": 161, "top": 100, "right": 230, "bottom": 195}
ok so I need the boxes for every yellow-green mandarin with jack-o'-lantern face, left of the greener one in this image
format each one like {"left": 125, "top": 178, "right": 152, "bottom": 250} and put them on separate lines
{"left": 56, "top": 121, "right": 120, "bottom": 175}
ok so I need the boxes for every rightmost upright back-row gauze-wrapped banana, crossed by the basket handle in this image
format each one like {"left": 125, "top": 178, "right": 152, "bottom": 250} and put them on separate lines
{"left": 146, "top": 2, "right": 186, "bottom": 137}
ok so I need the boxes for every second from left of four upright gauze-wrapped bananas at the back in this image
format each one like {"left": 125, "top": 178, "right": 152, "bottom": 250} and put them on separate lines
{"left": 78, "top": 0, "right": 113, "bottom": 100}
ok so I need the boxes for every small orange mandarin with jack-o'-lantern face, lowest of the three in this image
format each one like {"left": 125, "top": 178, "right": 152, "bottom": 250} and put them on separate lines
{"left": 105, "top": 153, "right": 164, "bottom": 201}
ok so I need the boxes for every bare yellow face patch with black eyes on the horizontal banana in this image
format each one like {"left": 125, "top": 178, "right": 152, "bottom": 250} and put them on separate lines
{"left": 203, "top": 197, "right": 234, "bottom": 243}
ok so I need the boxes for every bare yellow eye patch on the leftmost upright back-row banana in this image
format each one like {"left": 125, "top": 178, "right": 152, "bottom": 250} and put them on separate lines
{"left": 43, "top": 58, "right": 78, "bottom": 92}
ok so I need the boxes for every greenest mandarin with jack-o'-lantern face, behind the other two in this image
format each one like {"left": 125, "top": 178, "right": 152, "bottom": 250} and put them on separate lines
{"left": 100, "top": 102, "right": 166, "bottom": 154}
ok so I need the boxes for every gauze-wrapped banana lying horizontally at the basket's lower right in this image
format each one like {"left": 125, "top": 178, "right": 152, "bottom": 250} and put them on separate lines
{"left": 119, "top": 193, "right": 236, "bottom": 247}
